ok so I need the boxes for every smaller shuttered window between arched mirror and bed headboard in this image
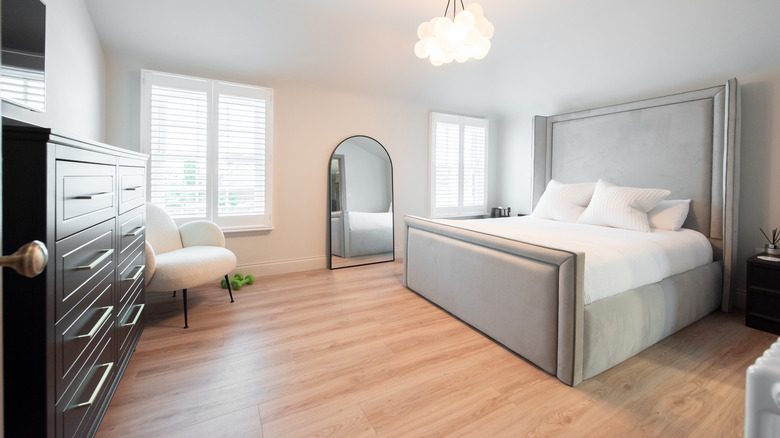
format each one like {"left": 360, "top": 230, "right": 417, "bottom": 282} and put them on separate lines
{"left": 430, "top": 113, "right": 488, "bottom": 217}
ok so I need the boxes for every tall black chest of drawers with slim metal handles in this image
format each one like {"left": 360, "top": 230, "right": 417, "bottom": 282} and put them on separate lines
{"left": 2, "top": 119, "right": 147, "bottom": 437}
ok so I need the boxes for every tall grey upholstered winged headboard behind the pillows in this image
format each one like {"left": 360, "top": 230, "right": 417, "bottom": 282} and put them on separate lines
{"left": 533, "top": 79, "right": 740, "bottom": 311}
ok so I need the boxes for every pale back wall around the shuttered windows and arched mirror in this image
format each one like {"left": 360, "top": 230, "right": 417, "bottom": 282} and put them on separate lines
{"left": 106, "top": 54, "right": 495, "bottom": 275}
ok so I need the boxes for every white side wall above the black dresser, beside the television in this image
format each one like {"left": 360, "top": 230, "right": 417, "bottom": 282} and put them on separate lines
{"left": 2, "top": 0, "right": 105, "bottom": 141}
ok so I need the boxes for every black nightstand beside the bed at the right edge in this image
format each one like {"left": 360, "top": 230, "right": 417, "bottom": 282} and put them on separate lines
{"left": 745, "top": 254, "right": 780, "bottom": 335}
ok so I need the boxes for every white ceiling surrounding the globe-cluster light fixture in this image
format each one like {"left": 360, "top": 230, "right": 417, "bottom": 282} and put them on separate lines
{"left": 85, "top": 0, "right": 780, "bottom": 113}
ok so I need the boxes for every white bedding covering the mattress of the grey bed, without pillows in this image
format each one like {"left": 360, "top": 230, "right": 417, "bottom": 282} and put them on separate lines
{"left": 432, "top": 216, "right": 712, "bottom": 305}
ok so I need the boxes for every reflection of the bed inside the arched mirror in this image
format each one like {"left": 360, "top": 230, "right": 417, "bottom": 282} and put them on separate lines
{"left": 331, "top": 211, "right": 394, "bottom": 258}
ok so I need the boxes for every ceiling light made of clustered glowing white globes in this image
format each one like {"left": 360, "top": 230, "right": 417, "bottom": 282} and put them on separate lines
{"left": 414, "top": 0, "right": 493, "bottom": 65}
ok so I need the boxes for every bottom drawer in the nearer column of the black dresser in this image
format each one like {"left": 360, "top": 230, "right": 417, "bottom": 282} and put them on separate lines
{"left": 56, "top": 323, "right": 118, "bottom": 437}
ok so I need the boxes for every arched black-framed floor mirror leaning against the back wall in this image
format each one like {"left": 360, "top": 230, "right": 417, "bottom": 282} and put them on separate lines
{"left": 328, "top": 135, "right": 395, "bottom": 269}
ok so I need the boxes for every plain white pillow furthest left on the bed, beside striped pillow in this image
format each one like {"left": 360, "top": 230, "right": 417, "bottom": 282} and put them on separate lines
{"left": 531, "top": 179, "right": 596, "bottom": 222}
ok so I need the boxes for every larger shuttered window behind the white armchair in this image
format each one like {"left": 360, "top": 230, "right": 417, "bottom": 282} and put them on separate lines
{"left": 141, "top": 70, "right": 273, "bottom": 231}
